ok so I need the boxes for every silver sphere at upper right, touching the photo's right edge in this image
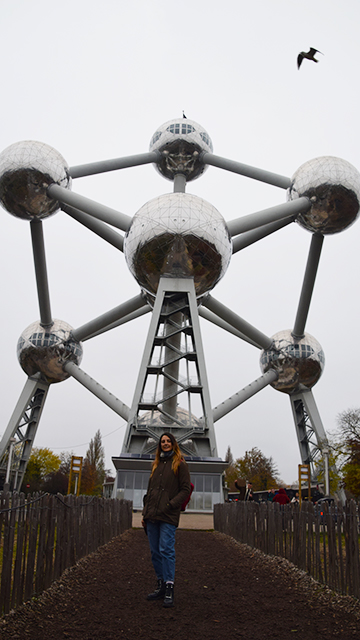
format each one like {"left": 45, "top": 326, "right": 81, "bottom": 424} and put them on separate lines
{"left": 287, "top": 156, "right": 360, "bottom": 234}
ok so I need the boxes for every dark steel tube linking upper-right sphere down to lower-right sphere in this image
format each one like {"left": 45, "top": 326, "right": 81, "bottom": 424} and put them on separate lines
{"left": 292, "top": 234, "right": 324, "bottom": 338}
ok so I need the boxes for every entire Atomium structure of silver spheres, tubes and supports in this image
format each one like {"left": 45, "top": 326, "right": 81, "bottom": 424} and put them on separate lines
{"left": 0, "top": 118, "right": 360, "bottom": 511}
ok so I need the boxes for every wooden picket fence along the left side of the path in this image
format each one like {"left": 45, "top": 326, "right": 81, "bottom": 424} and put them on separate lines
{"left": 0, "top": 493, "right": 132, "bottom": 615}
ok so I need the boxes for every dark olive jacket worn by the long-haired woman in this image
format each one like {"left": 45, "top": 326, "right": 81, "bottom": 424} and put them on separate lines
{"left": 143, "top": 457, "right": 191, "bottom": 527}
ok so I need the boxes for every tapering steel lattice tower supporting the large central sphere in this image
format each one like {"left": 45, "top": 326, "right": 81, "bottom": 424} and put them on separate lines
{"left": 123, "top": 277, "right": 217, "bottom": 458}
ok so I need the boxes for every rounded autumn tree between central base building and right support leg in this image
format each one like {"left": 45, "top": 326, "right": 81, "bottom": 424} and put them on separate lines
{"left": 235, "top": 447, "right": 281, "bottom": 491}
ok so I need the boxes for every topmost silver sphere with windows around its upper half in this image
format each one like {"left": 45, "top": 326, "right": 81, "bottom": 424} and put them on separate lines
{"left": 150, "top": 118, "right": 213, "bottom": 181}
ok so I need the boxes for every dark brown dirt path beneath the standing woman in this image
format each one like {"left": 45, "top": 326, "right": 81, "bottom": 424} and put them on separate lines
{"left": 0, "top": 529, "right": 360, "bottom": 640}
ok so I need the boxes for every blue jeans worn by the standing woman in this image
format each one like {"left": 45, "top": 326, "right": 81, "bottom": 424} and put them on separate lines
{"left": 146, "top": 520, "right": 176, "bottom": 582}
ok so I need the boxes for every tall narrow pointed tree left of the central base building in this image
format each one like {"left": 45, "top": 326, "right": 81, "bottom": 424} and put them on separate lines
{"left": 80, "top": 429, "right": 105, "bottom": 495}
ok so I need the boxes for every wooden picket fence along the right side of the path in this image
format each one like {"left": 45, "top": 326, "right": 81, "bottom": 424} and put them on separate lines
{"left": 214, "top": 501, "right": 360, "bottom": 598}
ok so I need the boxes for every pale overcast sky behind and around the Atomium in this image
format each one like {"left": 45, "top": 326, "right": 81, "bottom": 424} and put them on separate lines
{"left": 0, "top": 0, "right": 360, "bottom": 483}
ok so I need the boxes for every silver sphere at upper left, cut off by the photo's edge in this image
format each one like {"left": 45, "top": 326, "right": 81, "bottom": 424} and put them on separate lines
{"left": 0, "top": 140, "right": 71, "bottom": 220}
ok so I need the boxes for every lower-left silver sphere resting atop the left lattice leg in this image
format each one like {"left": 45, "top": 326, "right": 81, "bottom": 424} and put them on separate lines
{"left": 17, "top": 320, "right": 83, "bottom": 383}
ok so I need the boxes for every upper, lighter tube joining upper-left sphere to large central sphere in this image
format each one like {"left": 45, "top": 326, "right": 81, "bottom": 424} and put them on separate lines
{"left": 47, "top": 184, "right": 131, "bottom": 231}
